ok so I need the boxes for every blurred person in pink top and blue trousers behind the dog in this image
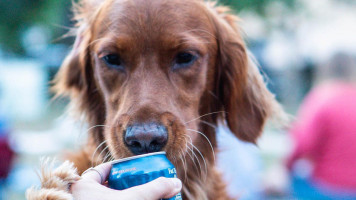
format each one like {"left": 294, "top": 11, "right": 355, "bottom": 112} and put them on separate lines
{"left": 287, "top": 54, "right": 356, "bottom": 200}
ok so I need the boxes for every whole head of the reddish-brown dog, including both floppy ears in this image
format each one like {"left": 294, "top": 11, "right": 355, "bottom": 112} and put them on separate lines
{"left": 54, "top": 0, "right": 278, "bottom": 164}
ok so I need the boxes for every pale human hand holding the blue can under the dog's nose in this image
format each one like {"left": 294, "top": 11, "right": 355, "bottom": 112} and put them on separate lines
{"left": 71, "top": 163, "right": 182, "bottom": 200}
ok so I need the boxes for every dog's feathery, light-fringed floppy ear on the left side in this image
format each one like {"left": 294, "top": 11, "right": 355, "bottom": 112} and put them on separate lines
{"left": 52, "top": 23, "right": 105, "bottom": 124}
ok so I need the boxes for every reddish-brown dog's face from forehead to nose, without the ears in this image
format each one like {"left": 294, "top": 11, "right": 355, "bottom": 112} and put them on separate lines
{"left": 91, "top": 0, "right": 217, "bottom": 157}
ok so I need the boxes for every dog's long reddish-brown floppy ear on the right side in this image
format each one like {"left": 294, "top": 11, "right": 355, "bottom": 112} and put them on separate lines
{"left": 211, "top": 7, "right": 282, "bottom": 143}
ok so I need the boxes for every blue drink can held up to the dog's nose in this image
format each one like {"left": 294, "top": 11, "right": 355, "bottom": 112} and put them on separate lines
{"left": 108, "top": 151, "right": 182, "bottom": 200}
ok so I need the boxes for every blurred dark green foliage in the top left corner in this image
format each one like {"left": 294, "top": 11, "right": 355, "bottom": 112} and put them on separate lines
{"left": 0, "top": 0, "right": 71, "bottom": 53}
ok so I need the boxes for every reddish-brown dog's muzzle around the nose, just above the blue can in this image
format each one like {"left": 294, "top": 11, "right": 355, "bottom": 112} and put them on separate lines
{"left": 93, "top": 113, "right": 192, "bottom": 162}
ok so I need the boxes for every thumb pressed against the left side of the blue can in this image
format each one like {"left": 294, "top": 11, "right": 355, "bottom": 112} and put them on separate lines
{"left": 82, "top": 162, "right": 111, "bottom": 184}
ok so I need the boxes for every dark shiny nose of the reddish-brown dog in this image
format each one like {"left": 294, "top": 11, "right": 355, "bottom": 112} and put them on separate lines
{"left": 124, "top": 123, "right": 168, "bottom": 155}
